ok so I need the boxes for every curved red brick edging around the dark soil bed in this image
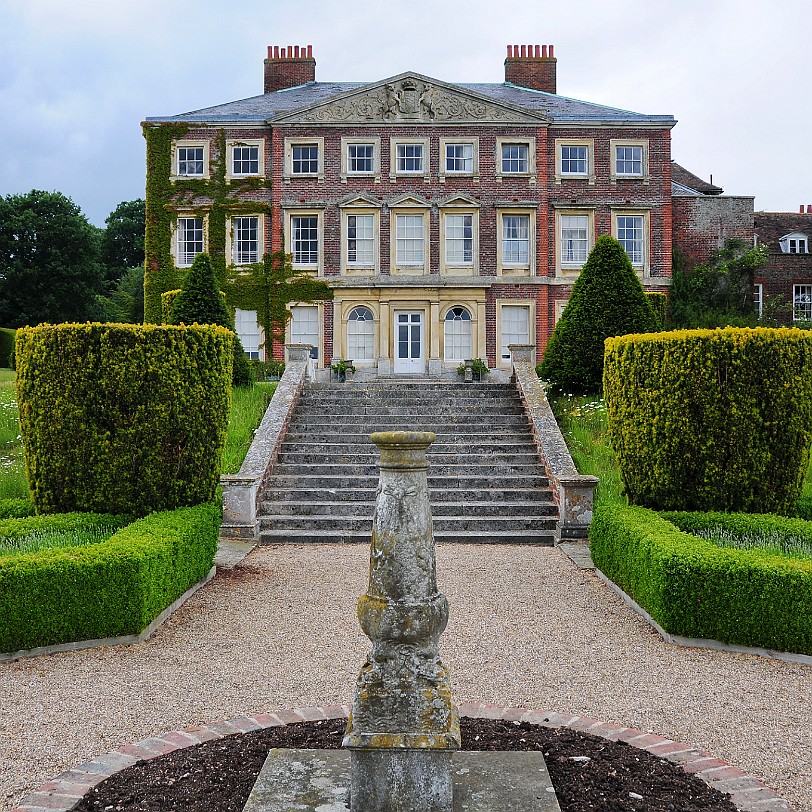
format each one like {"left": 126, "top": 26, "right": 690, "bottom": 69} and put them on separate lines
{"left": 12, "top": 702, "right": 792, "bottom": 812}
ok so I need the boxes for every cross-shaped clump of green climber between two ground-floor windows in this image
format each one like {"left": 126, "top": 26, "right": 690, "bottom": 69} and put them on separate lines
{"left": 229, "top": 251, "right": 333, "bottom": 356}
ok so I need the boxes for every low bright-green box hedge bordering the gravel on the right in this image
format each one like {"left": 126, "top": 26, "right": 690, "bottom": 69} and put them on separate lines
{"left": 590, "top": 505, "right": 812, "bottom": 654}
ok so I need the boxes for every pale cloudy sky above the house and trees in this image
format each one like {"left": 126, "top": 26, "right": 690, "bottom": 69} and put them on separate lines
{"left": 0, "top": 0, "right": 812, "bottom": 225}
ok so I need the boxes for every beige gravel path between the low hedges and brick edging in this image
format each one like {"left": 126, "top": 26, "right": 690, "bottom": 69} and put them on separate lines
{"left": 0, "top": 545, "right": 812, "bottom": 812}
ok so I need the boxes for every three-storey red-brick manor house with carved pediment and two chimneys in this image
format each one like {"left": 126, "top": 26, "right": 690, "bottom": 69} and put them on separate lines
{"left": 144, "top": 45, "right": 680, "bottom": 376}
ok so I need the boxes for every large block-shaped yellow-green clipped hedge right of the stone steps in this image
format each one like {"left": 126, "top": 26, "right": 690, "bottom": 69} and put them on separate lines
{"left": 603, "top": 327, "right": 812, "bottom": 514}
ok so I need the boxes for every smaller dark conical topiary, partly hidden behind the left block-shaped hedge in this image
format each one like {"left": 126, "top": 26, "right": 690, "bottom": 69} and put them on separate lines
{"left": 169, "top": 254, "right": 251, "bottom": 386}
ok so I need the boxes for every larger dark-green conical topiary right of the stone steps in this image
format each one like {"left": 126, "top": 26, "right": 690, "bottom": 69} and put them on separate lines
{"left": 539, "top": 235, "right": 657, "bottom": 394}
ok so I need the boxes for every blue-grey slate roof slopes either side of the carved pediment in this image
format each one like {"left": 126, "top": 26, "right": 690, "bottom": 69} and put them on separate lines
{"left": 146, "top": 80, "right": 676, "bottom": 127}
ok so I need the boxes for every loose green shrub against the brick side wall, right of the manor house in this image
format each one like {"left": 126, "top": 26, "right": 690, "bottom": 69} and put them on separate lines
{"left": 669, "top": 240, "right": 767, "bottom": 328}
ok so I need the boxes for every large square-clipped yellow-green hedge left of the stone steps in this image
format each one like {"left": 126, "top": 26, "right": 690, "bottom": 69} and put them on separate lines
{"left": 17, "top": 324, "right": 233, "bottom": 516}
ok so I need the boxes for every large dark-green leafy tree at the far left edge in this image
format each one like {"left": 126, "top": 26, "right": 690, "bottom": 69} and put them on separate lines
{"left": 0, "top": 189, "right": 104, "bottom": 327}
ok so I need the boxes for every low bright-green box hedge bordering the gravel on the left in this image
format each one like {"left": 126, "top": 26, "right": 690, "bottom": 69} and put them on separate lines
{"left": 0, "top": 504, "right": 221, "bottom": 652}
